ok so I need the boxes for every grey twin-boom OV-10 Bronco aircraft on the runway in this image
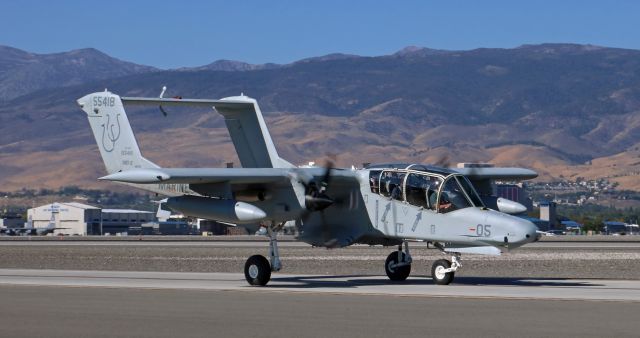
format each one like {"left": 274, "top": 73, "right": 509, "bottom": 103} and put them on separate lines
{"left": 78, "top": 91, "right": 538, "bottom": 285}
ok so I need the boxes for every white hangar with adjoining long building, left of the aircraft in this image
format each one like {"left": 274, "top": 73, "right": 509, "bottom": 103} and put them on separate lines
{"left": 27, "top": 202, "right": 155, "bottom": 235}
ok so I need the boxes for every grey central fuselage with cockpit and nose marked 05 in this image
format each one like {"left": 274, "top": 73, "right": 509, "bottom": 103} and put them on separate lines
{"left": 301, "top": 164, "right": 538, "bottom": 254}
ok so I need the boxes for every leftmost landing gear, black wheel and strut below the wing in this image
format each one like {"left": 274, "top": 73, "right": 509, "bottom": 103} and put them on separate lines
{"left": 244, "top": 223, "right": 283, "bottom": 286}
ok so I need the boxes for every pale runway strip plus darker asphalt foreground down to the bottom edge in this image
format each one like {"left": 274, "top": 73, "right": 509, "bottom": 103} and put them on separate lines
{"left": 0, "top": 269, "right": 640, "bottom": 337}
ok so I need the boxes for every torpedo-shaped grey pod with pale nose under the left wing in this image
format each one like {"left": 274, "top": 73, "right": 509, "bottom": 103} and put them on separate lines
{"left": 166, "top": 196, "right": 267, "bottom": 224}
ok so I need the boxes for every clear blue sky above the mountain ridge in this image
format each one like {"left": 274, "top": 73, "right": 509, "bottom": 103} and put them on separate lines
{"left": 0, "top": 0, "right": 640, "bottom": 68}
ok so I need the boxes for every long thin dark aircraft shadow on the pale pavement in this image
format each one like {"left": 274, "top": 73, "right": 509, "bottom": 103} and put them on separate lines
{"left": 271, "top": 275, "right": 604, "bottom": 289}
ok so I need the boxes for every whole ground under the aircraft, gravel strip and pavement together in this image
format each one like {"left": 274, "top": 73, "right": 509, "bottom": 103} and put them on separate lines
{"left": 0, "top": 240, "right": 640, "bottom": 337}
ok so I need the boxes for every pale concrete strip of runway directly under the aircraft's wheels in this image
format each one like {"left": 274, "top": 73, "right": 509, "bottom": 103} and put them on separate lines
{"left": 0, "top": 269, "right": 640, "bottom": 302}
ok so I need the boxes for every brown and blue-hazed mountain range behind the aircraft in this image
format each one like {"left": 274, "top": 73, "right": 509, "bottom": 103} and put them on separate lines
{"left": 0, "top": 44, "right": 640, "bottom": 190}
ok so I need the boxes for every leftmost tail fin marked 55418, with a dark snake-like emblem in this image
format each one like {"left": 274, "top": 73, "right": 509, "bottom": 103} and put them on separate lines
{"left": 78, "top": 91, "right": 159, "bottom": 174}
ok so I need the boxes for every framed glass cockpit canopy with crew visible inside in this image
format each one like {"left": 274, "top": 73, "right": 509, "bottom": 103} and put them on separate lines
{"left": 367, "top": 164, "right": 484, "bottom": 213}
